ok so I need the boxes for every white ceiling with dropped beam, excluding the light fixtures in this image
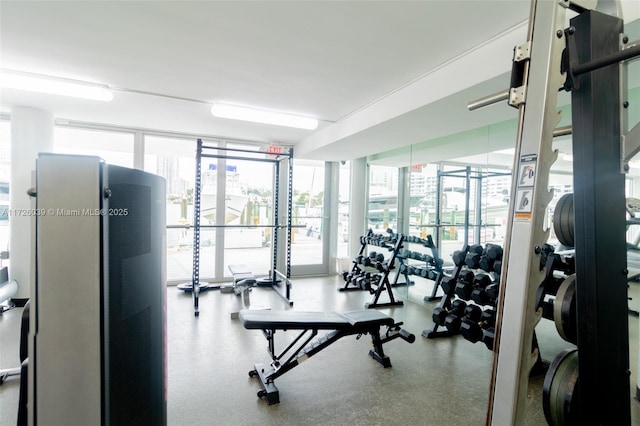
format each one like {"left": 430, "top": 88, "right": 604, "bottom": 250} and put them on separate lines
{"left": 0, "top": 0, "right": 640, "bottom": 160}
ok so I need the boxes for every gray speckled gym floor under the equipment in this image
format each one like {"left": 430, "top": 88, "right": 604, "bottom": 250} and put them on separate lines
{"left": 0, "top": 277, "right": 640, "bottom": 426}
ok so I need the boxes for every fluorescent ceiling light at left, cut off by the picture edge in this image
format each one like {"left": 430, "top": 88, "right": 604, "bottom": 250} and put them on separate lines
{"left": 0, "top": 70, "right": 113, "bottom": 101}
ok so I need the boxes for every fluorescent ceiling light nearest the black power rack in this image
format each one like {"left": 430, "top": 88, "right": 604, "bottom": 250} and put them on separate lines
{"left": 211, "top": 103, "right": 318, "bottom": 130}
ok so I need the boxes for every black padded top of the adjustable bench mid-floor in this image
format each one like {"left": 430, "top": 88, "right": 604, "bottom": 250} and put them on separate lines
{"left": 239, "top": 309, "right": 394, "bottom": 330}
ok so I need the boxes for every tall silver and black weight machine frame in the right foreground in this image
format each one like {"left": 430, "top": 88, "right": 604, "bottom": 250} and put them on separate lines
{"left": 469, "top": 0, "right": 640, "bottom": 425}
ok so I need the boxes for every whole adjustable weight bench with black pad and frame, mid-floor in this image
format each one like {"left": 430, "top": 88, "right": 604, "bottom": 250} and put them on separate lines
{"left": 239, "top": 309, "right": 415, "bottom": 405}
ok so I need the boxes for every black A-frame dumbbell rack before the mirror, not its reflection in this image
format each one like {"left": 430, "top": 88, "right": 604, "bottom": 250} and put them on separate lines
{"left": 338, "top": 229, "right": 404, "bottom": 309}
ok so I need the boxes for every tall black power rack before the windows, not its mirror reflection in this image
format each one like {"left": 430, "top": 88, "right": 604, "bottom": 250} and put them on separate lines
{"left": 191, "top": 139, "right": 293, "bottom": 316}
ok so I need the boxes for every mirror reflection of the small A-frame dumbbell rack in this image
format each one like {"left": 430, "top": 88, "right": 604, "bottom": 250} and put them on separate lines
{"left": 392, "top": 235, "right": 444, "bottom": 302}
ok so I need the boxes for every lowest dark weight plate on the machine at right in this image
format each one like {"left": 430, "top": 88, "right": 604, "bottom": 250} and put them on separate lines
{"left": 542, "top": 349, "right": 580, "bottom": 426}
